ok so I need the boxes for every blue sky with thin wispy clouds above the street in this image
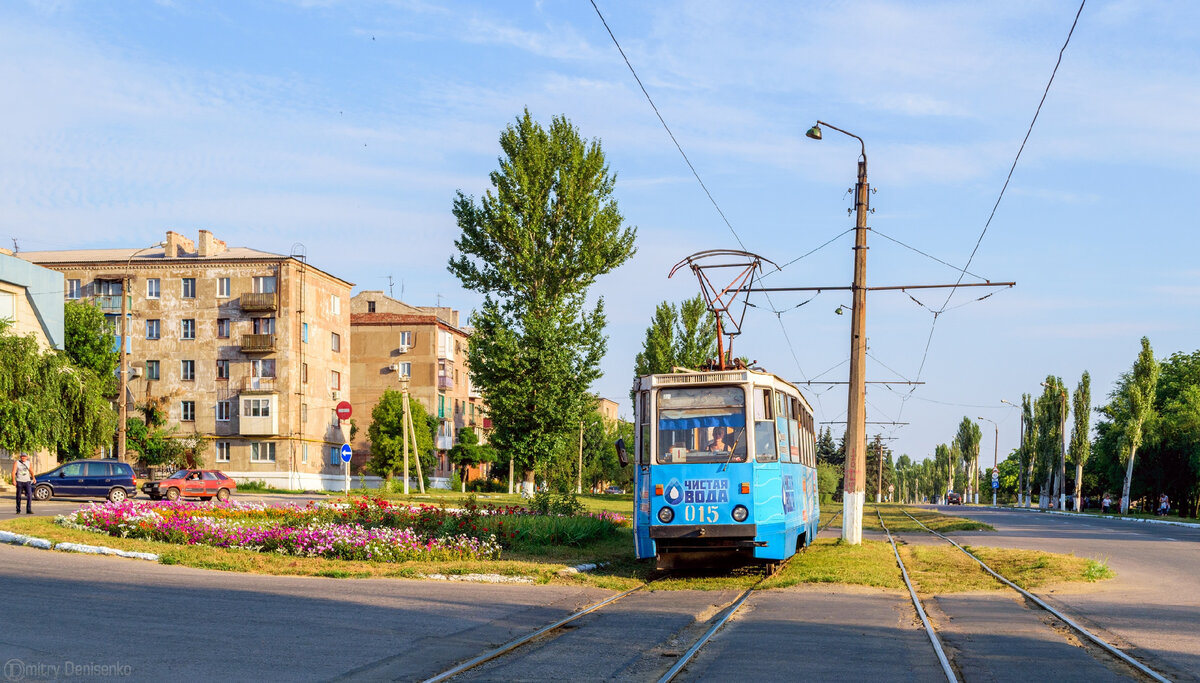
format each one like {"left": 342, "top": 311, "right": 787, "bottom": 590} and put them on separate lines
{"left": 0, "top": 0, "right": 1200, "bottom": 457}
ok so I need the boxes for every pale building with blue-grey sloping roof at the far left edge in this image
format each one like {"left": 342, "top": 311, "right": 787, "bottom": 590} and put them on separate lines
{"left": 0, "top": 248, "right": 64, "bottom": 349}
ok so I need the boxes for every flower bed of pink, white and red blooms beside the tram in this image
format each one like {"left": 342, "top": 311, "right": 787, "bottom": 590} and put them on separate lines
{"left": 56, "top": 498, "right": 624, "bottom": 562}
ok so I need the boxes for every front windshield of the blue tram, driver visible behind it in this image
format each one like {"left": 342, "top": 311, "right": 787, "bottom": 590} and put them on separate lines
{"left": 658, "top": 387, "right": 746, "bottom": 465}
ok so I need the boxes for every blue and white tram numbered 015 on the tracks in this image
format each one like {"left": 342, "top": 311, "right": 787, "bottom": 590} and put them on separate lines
{"left": 631, "top": 370, "right": 820, "bottom": 569}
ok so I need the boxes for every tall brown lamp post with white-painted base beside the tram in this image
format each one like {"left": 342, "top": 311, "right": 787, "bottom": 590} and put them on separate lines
{"left": 804, "top": 121, "right": 870, "bottom": 545}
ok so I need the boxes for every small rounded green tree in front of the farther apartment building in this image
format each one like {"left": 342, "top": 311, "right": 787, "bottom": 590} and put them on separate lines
{"left": 367, "top": 389, "right": 437, "bottom": 489}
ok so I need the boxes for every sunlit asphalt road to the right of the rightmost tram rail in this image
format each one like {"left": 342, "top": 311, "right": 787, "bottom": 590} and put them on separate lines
{"left": 904, "top": 505, "right": 1200, "bottom": 681}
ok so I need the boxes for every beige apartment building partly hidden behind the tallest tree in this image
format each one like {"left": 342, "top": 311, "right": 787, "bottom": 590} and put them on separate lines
{"left": 350, "top": 290, "right": 492, "bottom": 486}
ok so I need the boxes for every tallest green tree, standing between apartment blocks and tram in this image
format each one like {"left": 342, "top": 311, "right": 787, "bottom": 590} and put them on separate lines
{"left": 449, "top": 110, "right": 636, "bottom": 493}
